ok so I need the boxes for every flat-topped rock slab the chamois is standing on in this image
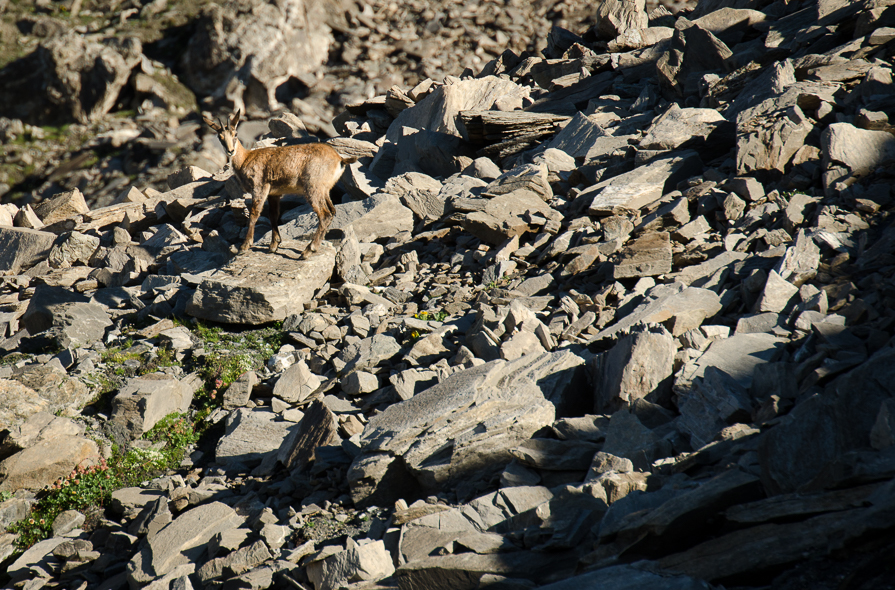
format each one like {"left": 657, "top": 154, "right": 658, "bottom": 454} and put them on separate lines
{"left": 186, "top": 241, "right": 336, "bottom": 324}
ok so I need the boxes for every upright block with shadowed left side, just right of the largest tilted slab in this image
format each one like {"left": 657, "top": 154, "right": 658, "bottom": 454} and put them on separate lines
{"left": 593, "top": 326, "right": 676, "bottom": 413}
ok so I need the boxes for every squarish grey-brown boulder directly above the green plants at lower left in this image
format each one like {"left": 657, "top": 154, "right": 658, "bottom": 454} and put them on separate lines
{"left": 110, "top": 373, "right": 199, "bottom": 439}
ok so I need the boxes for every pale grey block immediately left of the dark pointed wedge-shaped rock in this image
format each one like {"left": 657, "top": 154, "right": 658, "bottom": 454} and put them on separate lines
{"left": 215, "top": 408, "right": 295, "bottom": 467}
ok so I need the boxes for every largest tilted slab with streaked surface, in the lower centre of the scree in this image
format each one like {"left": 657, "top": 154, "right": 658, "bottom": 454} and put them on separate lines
{"left": 348, "top": 353, "right": 584, "bottom": 502}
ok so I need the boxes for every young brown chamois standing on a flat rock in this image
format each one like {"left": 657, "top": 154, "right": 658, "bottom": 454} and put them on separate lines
{"left": 203, "top": 111, "right": 356, "bottom": 258}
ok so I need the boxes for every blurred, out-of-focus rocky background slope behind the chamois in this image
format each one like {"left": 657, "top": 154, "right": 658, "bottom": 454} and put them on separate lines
{"left": 0, "top": 0, "right": 692, "bottom": 206}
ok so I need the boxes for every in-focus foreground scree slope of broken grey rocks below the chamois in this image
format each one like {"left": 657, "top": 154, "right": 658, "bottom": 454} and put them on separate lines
{"left": 0, "top": 0, "right": 895, "bottom": 590}
